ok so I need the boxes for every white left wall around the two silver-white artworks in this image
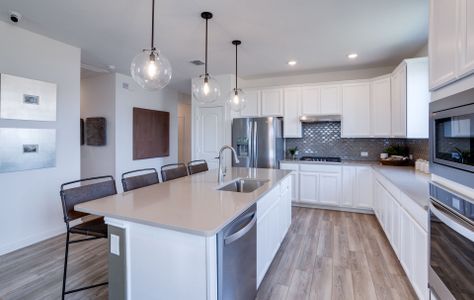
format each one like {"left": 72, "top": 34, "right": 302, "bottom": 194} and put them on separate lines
{"left": 0, "top": 22, "right": 80, "bottom": 255}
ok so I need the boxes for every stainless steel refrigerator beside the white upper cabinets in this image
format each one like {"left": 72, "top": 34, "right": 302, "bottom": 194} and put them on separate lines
{"left": 232, "top": 117, "right": 284, "bottom": 169}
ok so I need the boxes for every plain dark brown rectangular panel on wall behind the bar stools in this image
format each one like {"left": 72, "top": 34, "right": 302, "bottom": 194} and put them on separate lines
{"left": 133, "top": 107, "right": 170, "bottom": 160}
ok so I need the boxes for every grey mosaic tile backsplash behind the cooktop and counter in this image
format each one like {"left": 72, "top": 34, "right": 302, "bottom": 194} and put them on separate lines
{"left": 286, "top": 122, "right": 429, "bottom": 161}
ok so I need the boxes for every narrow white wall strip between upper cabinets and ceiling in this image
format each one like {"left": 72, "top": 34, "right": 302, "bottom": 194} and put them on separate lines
{"left": 239, "top": 66, "right": 395, "bottom": 88}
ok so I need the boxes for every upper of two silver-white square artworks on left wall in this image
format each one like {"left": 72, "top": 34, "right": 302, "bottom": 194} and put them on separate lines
{"left": 0, "top": 74, "right": 57, "bottom": 121}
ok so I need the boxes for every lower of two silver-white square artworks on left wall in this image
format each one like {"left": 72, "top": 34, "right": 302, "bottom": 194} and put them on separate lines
{"left": 0, "top": 128, "right": 56, "bottom": 173}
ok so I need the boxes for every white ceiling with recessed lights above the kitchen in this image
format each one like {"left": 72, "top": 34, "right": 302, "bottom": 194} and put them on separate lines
{"left": 0, "top": 0, "right": 428, "bottom": 93}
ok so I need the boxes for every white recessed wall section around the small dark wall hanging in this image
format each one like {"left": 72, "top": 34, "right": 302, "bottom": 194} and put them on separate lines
{"left": 81, "top": 74, "right": 115, "bottom": 178}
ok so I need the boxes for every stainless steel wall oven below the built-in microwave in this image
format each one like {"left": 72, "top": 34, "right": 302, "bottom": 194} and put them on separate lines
{"left": 428, "top": 183, "right": 474, "bottom": 300}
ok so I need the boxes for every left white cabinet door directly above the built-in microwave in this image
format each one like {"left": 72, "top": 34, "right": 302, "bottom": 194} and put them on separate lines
{"left": 428, "top": 0, "right": 459, "bottom": 90}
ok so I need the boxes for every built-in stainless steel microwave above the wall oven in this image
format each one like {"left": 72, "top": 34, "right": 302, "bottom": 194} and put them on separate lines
{"left": 430, "top": 89, "right": 474, "bottom": 188}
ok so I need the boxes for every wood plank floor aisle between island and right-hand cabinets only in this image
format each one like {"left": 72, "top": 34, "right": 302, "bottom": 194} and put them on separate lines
{"left": 257, "top": 207, "right": 417, "bottom": 300}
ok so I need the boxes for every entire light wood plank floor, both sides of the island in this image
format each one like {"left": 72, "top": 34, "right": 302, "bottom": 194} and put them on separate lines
{"left": 0, "top": 208, "right": 416, "bottom": 300}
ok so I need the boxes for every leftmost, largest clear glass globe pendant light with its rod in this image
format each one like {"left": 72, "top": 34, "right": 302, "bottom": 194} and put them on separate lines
{"left": 130, "top": 0, "right": 172, "bottom": 90}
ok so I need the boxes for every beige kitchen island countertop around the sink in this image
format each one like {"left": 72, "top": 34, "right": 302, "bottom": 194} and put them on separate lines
{"left": 74, "top": 168, "right": 291, "bottom": 236}
